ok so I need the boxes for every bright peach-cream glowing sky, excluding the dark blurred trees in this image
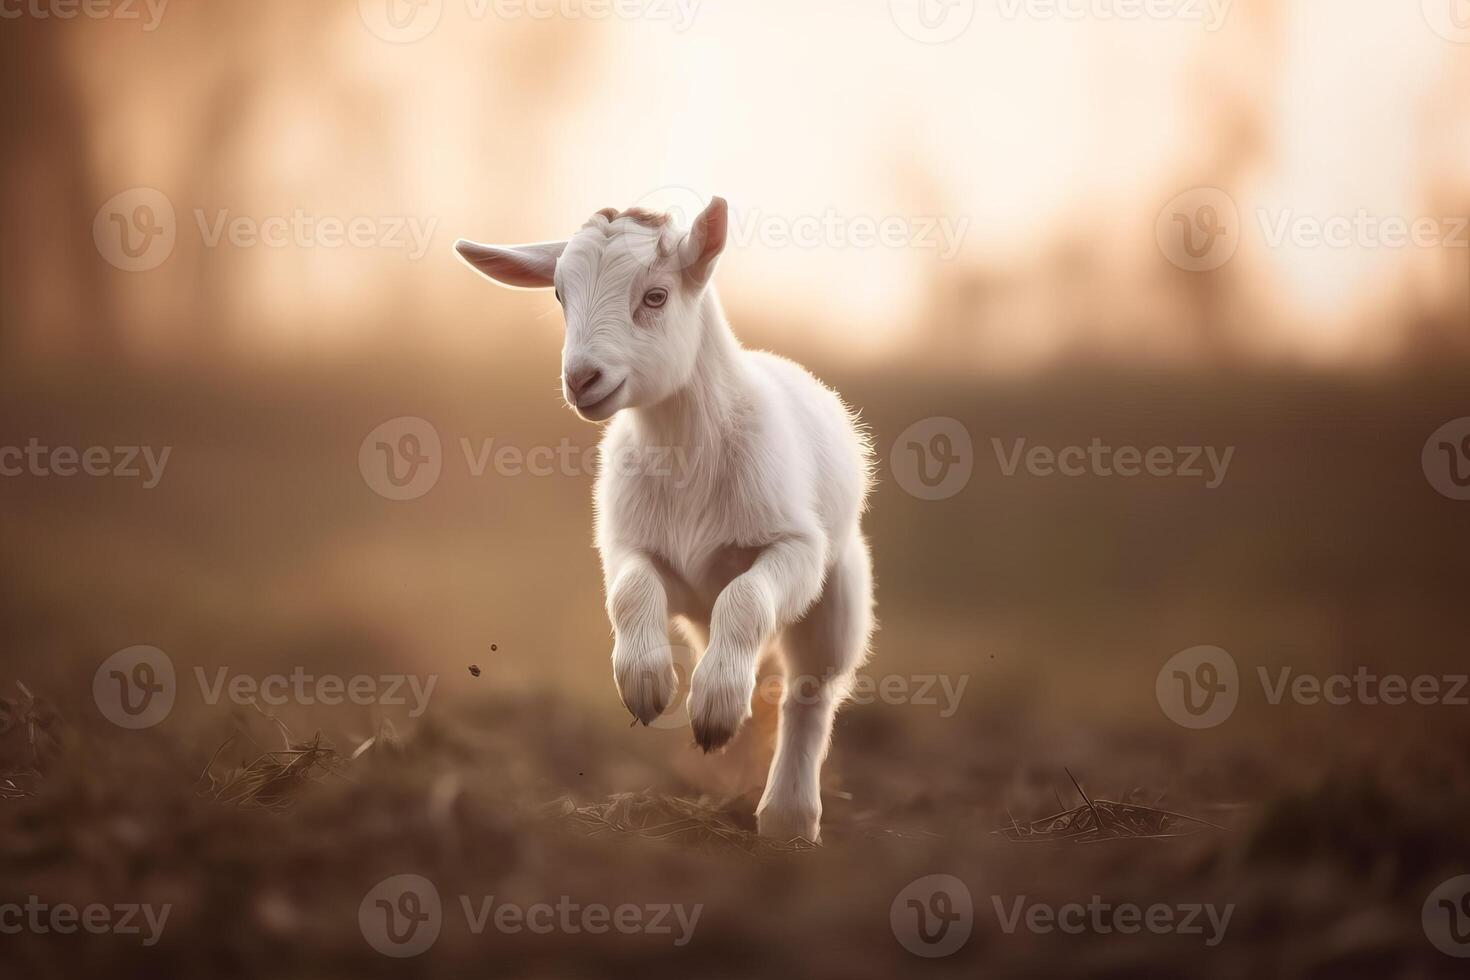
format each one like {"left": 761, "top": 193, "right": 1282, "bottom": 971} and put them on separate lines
{"left": 69, "top": 0, "right": 1470, "bottom": 365}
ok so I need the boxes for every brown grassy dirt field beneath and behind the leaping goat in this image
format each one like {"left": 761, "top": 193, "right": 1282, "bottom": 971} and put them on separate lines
{"left": 0, "top": 358, "right": 1470, "bottom": 980}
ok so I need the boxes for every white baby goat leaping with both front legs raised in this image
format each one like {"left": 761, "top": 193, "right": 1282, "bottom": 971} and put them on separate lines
{"left": 456, "top": 197, "right": 873, "bottom": 842}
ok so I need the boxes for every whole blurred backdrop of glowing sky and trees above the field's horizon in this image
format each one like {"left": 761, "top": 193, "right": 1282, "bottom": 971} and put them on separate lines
{"left": 3, "top": 0, "right": 1470, "bottom": 372}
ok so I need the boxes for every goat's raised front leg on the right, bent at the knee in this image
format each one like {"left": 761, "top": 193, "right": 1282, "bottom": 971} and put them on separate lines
{"left": 689, "top": 536, "right": 826, "bottom": 752}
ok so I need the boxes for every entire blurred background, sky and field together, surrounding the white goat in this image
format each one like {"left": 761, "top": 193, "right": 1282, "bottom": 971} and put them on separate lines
{"left": 0, "top": 0, "right": 1470, "bottom": 977}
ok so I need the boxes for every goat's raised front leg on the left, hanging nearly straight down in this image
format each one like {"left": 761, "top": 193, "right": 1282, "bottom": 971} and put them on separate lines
{"left": 607, "top": 554, "right": 679, "bottom": 724}
